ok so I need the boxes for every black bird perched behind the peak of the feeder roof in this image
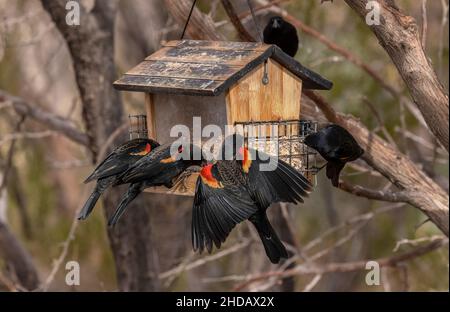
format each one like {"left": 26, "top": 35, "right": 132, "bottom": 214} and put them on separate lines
{"left": 263, "top": 16, "right": 298, "bottom": 57}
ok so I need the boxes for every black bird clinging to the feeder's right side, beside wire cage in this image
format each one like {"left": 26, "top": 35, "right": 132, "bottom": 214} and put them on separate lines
{"left": 304, "top": 125, "right": 364, "bottom": 187}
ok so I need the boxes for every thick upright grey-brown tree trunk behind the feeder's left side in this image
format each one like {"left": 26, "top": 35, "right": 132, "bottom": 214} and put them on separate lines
{"left": 42, "top": 0, "right": 157, "bottom": 291}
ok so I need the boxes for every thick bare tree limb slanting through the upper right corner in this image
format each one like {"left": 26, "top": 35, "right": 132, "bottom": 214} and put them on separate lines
{"left": 345, "top": 0, "right": 449, "bottom": 151}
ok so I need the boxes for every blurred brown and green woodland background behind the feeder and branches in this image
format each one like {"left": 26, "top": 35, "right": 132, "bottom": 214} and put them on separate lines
{"left": 0, "top": 0, "right": 449, "bottom": 291}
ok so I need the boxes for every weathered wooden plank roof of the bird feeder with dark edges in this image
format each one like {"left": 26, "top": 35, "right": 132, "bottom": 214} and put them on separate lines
{"left": 114, "top": 40, "right": 333, "bottom": 96}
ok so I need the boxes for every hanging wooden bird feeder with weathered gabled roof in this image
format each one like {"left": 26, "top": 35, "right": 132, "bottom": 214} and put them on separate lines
{"left": 114, "top": 40, "right": 332, "bottom": 195}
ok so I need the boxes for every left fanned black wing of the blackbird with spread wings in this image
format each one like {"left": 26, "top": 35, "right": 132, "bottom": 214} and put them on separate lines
{"left": 192, "top": 166, "right": 257, "bottom": 252}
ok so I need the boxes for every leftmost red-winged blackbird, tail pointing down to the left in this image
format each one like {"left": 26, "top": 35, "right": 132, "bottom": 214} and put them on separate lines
{"left": 78, "top": 139, "right": 159, "bottom": 220}
